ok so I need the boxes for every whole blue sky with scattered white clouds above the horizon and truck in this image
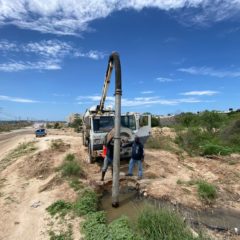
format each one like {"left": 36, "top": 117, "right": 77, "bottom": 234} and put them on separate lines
{"left": 0, "top": 0, "right": 240, "bottom": 120}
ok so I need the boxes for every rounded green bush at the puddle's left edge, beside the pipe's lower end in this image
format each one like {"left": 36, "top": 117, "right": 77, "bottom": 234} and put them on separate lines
{"left": 74, "top": 189, "right": 98, "bottom": 216}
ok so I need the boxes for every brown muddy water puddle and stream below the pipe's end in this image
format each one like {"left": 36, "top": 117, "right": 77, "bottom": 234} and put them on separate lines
{"left": 101, "top": 188, "right": 240, "bottom": 231}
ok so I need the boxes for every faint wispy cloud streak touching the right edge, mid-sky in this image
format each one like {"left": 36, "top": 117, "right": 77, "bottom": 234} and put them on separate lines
{"left": 178, "top": 67, "right": 240, "bottom": 78}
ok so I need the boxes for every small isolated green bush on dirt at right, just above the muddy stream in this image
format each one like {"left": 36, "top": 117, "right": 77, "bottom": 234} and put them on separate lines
{"left": 197, "top": 181, "right": 217, "bottom": 203}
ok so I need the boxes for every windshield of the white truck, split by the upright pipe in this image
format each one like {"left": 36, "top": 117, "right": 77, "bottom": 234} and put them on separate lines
{"left": 93, "top": 115, "right": 136, "bottom": 132}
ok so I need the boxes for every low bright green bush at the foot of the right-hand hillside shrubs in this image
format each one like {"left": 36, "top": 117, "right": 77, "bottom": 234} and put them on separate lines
{"left": 202, "top": 143, "right": 234, "bottom": 156}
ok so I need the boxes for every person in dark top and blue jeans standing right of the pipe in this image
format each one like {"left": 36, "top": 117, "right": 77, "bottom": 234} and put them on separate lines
{"left": 123, "top": 136, "right": 144, "bottom": 180}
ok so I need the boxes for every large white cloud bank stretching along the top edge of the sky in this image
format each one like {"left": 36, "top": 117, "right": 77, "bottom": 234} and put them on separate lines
{"left": 0, "top": 0, "right": 240, "bottom": 35}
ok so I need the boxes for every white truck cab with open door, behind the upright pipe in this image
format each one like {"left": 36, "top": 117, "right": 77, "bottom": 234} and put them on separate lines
{"left": 82, "top": 107, "right": 151, "bottom": 163}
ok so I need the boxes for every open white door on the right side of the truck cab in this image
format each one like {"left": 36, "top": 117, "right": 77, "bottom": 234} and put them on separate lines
{"left": 136, "top": 115, "right": 151, "bottom": 144}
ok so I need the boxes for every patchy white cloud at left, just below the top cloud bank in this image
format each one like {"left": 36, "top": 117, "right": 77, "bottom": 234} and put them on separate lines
{"left": 0, "top": 39, "right": 105, "bottom": 72}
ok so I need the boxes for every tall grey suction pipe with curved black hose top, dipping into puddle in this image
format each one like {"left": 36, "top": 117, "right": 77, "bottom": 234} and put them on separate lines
{"left": 108, "top": 52, "right": 122, "bottom": 207}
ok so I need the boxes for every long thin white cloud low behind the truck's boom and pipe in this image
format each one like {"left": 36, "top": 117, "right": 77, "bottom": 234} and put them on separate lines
{"left": 76, "top": 95, "right": 206, "bottom": 107}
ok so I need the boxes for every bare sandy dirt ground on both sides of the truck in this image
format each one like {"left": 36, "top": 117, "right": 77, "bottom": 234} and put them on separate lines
{"left": 0, "top": 128, "right": 240, "bottom": 240}
